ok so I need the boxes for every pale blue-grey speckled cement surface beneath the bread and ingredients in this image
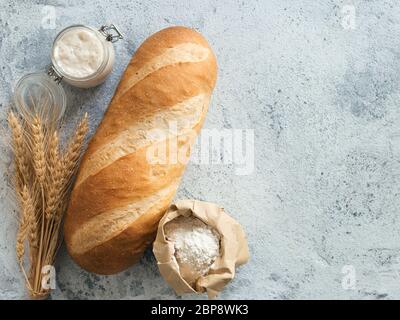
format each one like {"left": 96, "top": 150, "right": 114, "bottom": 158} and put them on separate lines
{"left": 0, "top": 0, "right": 400, "bottom": 299}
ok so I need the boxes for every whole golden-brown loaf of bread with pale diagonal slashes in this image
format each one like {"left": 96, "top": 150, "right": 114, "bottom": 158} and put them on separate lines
{"left": 64, "top": 27, "right": 217, "bottom": 274}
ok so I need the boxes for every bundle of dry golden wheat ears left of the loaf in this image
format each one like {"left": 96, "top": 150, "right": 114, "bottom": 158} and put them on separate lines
{"left": 8, "top": 112, "right": 88, "bottom": 298}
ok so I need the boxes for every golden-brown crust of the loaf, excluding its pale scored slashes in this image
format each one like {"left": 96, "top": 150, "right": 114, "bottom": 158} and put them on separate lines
{"left": 64, "top": 27, "right": 217, "bottom": 274}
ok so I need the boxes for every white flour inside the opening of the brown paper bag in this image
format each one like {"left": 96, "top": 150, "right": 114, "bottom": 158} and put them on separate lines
{"left": 164, "top": 216, "right": 220, "bottom": 284}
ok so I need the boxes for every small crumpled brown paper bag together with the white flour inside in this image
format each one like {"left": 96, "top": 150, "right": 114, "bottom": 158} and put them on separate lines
{"left": 153, "top": 200, "right": 249, "bottom": 299}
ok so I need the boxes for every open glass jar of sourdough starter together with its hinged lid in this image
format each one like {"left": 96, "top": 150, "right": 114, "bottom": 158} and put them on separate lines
{"left": 14, "top": 24, "right": 123, "bottom": 123}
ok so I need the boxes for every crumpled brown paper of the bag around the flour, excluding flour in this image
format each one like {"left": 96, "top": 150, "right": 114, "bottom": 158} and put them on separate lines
{"left": 153, "top": 200, "right": 249, "bottom": 299}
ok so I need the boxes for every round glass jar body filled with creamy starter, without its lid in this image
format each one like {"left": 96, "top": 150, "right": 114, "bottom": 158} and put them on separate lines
{"left": 51, "top": 25, "right": 122, "bottom": 88}
